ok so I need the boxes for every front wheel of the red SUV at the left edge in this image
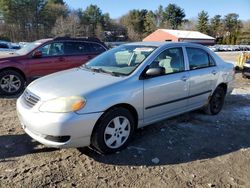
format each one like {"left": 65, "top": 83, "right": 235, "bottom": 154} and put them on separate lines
{"left": 0, "top": 70, "right": 25, "bottom": 96}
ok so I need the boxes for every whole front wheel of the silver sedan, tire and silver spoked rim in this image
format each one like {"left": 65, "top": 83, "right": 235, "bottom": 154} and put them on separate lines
{"left": 91, "top": 108, "right": 135, "bottom": 154}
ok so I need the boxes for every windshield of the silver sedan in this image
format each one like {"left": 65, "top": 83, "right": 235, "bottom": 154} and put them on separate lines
{"left": 83, "top": 45, "right": 156, "bottom": 76}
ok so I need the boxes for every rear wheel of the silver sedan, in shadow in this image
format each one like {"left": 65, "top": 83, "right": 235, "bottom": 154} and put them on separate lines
{"left": 204, "top": 87, "right": 226, "bottom": 115}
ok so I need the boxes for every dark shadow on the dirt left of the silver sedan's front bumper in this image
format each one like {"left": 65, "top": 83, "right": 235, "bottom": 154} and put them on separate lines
{"left": 0, "top": 134, "right": 57, "bottom": 162}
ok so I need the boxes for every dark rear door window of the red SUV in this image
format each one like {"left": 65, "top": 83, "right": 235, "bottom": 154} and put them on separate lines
{"left": 64, "top": 42, "right": 90, "bottom": 55}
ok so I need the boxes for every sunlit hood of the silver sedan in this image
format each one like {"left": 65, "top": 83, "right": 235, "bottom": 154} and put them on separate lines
{"left": 27, "top": 68, "right": 124, "bottom": 101}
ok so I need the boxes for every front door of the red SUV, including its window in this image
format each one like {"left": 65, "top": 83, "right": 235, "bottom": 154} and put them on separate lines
{"left": 26, "top": 42, "right": 68, "bottom": 78}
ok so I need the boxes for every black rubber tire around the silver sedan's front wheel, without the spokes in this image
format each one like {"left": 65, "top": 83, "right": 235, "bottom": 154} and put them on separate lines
{"left": 91, "top": 108, "right": 135, "bottom": 154}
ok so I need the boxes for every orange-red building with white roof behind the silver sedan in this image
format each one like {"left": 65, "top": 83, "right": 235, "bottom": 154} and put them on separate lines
{"left": 143, "top": 29, "right": 215, "bottom": 45}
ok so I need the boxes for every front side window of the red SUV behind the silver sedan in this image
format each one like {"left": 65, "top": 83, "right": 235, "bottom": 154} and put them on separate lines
{"left": 38, "top": 42, "right": 64, "bottom": 57}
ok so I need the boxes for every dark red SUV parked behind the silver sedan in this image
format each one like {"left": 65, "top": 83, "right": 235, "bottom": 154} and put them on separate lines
{"left": 0, "top": 37, "right": 107, "bottom": 95}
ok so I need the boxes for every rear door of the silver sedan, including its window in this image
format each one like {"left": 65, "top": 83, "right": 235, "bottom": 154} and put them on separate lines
{"left": 186, "top": 47, "right": 218, "bottom": 108}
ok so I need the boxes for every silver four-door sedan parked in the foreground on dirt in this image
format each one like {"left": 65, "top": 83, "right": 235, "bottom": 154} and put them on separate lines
{"left": 17, "top": 42, "right": 234, "bottom": 154}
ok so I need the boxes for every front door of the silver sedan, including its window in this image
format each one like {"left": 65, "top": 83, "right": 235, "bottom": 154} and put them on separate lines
{"left": 144, "top": 47, "right": 188, "bottom": 124}
